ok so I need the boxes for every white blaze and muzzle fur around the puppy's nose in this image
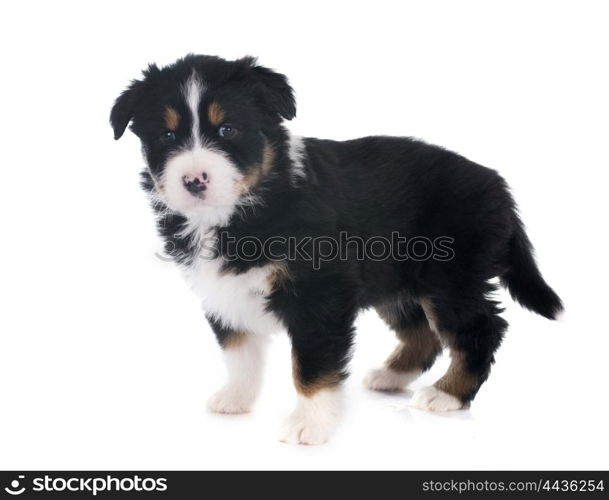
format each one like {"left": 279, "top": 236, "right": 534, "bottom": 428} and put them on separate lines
{"left": 161, "top": 73, "right": 243, "bottom": 225}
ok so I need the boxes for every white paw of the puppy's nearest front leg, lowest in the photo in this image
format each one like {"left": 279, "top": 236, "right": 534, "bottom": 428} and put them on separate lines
{"left": 279, "top": 391, "right": 340, "bottom": 445}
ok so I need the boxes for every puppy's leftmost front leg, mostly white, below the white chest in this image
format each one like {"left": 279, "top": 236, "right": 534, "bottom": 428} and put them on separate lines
{"left": 207, "top": 318, "right": 268, "bottom": 414}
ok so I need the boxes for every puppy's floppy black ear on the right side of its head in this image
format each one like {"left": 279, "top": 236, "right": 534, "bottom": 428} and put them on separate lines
{"left": 243, "top": 57, "right": 296, "bottom": 120}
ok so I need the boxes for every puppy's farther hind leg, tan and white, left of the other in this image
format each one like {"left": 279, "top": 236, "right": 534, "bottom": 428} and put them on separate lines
{"left": 364, "top": 300, "right": 442, "bottom": 391}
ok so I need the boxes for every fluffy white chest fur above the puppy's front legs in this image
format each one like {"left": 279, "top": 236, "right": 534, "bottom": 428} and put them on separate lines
{"left": 184, "top": 254, "right": 282, "bottom": 334}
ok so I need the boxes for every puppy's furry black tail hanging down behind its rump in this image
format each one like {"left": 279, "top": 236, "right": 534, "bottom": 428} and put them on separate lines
{"left": 501, "top": 216, "right": 563, "bottom": 319}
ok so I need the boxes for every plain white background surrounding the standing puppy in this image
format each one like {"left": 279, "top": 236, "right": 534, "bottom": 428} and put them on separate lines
{"left": 0, "top": 0, "right": 609, "bottom": 470}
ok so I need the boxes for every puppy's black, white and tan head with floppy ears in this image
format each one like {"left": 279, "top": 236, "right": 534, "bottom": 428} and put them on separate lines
{"left": 110, "top": 55, "right": 296, "bottom": 223}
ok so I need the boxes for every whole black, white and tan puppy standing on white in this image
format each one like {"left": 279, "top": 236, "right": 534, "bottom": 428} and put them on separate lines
{"left": 110, "top": 55, "right": 562, "bottom": 444}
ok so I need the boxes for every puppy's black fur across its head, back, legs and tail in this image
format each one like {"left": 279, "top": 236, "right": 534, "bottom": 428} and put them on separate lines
{"left": 111, "top": 56, "right": 562, "bottom": 401}
